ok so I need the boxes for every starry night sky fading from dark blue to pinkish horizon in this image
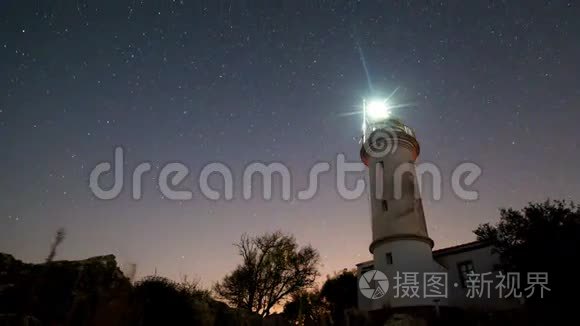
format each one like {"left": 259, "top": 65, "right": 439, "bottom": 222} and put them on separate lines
{"left": 0, "top": 0, "right": 580, "bottom": 285}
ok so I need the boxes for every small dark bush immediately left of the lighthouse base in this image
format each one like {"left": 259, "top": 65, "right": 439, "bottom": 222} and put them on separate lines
{"left": 320, "top": 269, "right": 358, "bottom": 325}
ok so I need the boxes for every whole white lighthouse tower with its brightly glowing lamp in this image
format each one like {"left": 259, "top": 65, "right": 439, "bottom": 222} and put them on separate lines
{"left": 360, "top": 101, "right": 447, "bottom": 310}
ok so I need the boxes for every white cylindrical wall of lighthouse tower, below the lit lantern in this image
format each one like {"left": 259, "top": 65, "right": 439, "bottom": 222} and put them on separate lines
{"left": 363, "top": 129, "right": 447, "bottom": 310}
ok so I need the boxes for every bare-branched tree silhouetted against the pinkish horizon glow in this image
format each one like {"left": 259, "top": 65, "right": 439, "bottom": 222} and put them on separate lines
{"left": 214, "top": 232, "right": 320, "bottom": 316}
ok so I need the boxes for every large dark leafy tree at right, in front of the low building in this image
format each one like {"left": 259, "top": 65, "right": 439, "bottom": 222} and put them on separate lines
{"left": 474, "top": 200, "right": 580, "bottom": 322}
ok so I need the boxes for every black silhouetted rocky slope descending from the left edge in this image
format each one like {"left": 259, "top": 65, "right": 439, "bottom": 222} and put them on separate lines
{"left": 0, "top": 253, "right": 262, "bottom": 326}
